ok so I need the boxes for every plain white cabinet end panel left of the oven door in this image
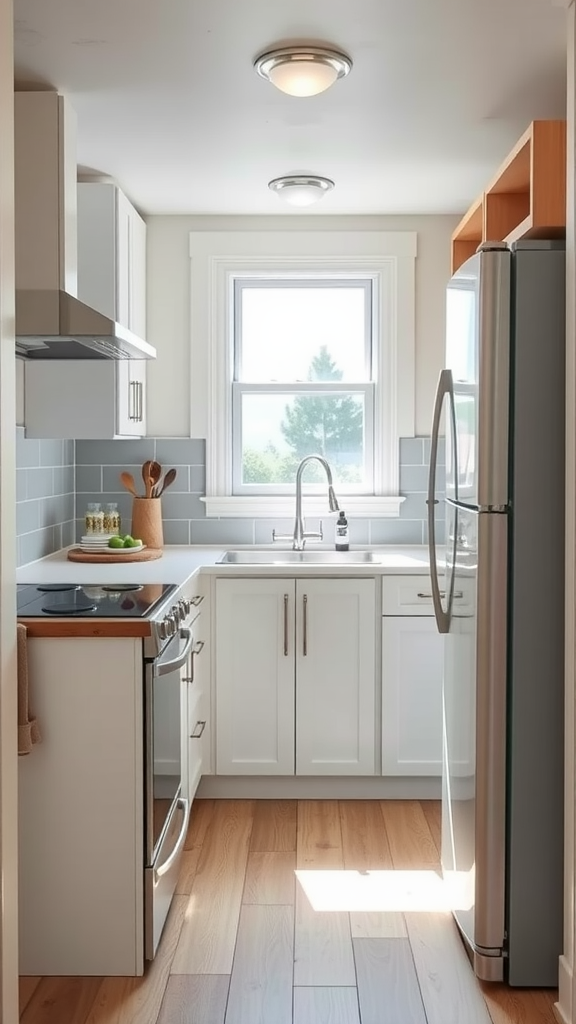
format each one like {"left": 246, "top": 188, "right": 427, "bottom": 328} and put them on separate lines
{"left": 18, "top": 637, "right": 145, "bottom": 976}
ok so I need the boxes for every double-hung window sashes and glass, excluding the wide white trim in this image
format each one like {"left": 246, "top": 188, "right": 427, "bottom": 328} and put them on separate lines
{"left": 232, "top": 274, "right": 377, "bottom": 495}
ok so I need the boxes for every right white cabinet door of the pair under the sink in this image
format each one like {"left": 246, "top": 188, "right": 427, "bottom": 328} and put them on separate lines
{"left": 296, "top": 579, "right": 376, "bottom": 775}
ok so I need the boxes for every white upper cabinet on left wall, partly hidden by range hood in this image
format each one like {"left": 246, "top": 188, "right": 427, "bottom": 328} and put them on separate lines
{"left": 25, "top": 181, "right": 147, "bottom": 439}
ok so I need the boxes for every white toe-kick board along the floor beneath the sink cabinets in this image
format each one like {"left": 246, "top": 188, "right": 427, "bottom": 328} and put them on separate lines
{"left": 196, "top": 775, "right": 442, "bottom": 800}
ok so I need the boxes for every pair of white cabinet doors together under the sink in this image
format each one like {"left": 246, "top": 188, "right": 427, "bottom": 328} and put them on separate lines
{"left": 215, "top": 578, "right": 375, "bottom": 775}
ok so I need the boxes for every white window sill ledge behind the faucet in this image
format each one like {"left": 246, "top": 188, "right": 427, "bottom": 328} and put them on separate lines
{"left": 201, "top": 495, "right": 405, "bottom": 519}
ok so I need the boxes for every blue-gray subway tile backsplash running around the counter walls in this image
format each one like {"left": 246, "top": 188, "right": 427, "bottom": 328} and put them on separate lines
{"left": 16, "top": 427, "right": 444, "bottom": 564}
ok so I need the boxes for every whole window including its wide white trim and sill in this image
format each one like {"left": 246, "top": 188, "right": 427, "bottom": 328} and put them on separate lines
{"left": 190, "top": 229, "right": 416, "bottom": 520}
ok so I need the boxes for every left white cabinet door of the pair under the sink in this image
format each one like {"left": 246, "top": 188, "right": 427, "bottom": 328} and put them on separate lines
{"left": 215, "top": 579, "right": 294, "bottom": 775}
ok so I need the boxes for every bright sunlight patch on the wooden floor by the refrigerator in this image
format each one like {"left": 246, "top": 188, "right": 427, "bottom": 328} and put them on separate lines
{"left": 295, "top": 870, "right": 474, "bottom": 912}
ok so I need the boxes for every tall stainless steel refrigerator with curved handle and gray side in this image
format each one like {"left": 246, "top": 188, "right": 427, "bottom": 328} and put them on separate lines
{"left": 427, "top": 240, "right": 566, "bottom": 986}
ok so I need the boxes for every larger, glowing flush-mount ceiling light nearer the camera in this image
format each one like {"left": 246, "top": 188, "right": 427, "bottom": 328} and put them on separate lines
{"left": 254, "top": 46, "right": 352, "bottom": 96}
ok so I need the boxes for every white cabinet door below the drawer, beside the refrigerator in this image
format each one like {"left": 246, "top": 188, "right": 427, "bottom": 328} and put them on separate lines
{"left": 382, "top": 615, "right": 443, "bottom": 775}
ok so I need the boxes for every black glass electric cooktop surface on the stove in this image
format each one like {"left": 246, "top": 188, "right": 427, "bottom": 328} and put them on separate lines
{"left": 16, "top": 583, "right": 176, "bottom": 618}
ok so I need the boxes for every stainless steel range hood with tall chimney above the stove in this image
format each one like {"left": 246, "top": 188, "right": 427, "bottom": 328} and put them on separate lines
{"left": 14, "top": 92, "right": 156, "bottom": 359}
